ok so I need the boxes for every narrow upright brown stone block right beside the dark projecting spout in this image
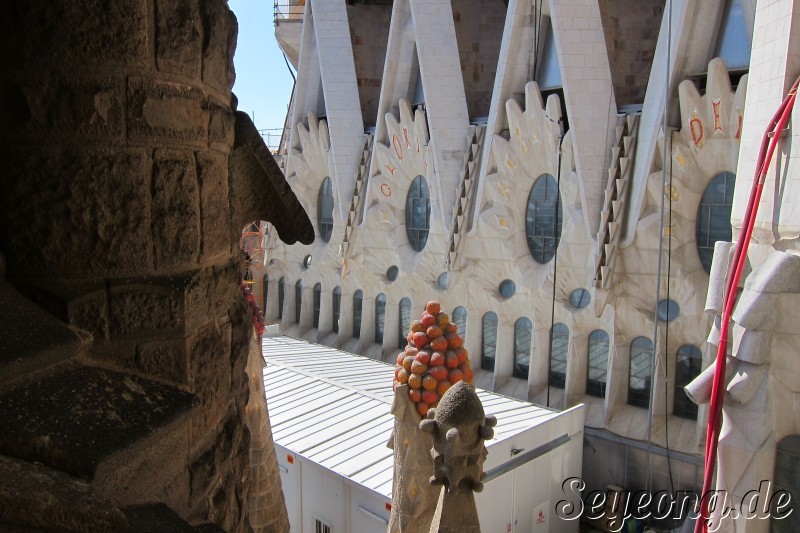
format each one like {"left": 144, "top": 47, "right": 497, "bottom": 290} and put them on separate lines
{"left": 197, "top": 152, "right": 232, "bottom": 261}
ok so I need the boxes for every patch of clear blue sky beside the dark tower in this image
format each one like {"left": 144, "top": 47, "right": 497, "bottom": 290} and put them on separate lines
{"left": 228, "top": 0, "right": 292, "bottom": 147}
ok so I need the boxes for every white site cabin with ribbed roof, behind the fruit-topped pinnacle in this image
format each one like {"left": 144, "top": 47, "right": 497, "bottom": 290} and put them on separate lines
{"left": 263, "top": 336, "right": 584, "bottom": 533}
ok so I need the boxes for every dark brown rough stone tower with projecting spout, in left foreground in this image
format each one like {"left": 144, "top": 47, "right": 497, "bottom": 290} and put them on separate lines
{"left": 0, "top": 0, "right": 313, "bottom": 531}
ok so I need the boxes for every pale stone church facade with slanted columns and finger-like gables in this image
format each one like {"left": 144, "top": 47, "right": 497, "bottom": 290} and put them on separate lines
{"left": 266, "top": 0, "right": 800, "bottom": 531}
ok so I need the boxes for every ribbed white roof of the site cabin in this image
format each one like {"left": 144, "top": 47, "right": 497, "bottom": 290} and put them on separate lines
{"left": 262, "top": 336, "right": 561, "bottom": 498}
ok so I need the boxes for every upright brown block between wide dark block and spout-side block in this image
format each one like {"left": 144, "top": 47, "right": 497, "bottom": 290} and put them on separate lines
{"left": 152, "top": 150, "right": 200, "bottom": 269}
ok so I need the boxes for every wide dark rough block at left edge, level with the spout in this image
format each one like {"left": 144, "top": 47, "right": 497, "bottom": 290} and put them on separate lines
{"left": 0, "top": 148, "right": 151, "bottom": 279}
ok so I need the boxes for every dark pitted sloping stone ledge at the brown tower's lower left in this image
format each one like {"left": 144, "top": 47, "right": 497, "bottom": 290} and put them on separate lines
{"left": 0, "top": 367, "right": 194, "bottom": 477}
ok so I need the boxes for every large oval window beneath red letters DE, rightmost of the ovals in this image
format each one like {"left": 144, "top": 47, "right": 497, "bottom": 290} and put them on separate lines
{"left": 696, "top": 172, "right": 736, "bottom": 273}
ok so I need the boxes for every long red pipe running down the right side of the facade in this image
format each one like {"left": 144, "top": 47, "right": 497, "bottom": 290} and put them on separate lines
{"left": 695, "top": 77, "right": 800, "bottom": 533}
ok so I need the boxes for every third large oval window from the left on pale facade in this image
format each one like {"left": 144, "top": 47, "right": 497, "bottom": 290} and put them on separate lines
{"left": 525, "top": 174, "right": 562, "bottom": 264}
